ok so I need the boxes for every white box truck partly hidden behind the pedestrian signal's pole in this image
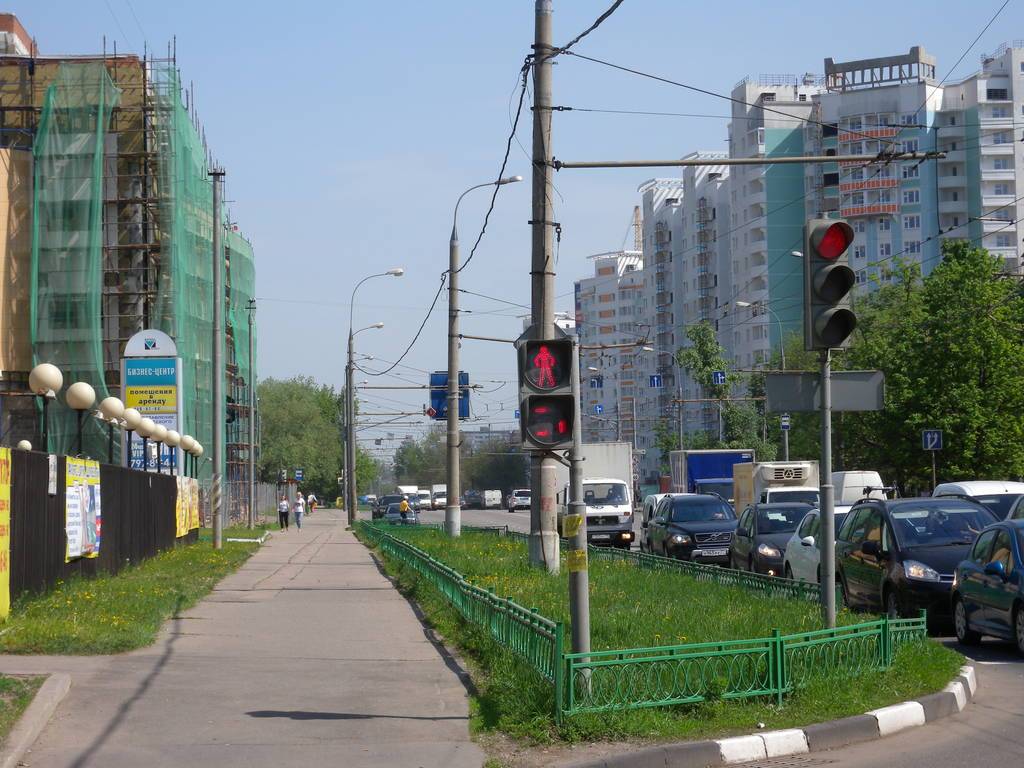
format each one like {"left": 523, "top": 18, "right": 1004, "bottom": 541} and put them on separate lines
{"left": 557, "top": 442, "right": 634, "bottom": 549}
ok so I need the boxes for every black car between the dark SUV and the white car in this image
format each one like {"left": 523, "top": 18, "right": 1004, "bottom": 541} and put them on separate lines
{"left": 729, "top": 504, "right": 814, "bottom": 575}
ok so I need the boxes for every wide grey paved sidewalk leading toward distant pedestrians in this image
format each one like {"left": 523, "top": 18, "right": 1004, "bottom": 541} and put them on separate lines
{"left": 0, "top": 510, "right": 484, "bottom": 768}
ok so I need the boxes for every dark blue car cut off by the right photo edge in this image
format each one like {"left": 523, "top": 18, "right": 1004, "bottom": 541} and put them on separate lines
{"left": 952, "top": 520, "right": 1024, "bottom": 654}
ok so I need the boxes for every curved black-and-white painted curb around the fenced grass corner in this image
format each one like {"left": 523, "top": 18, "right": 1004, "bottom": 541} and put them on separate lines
{"left": 557, "top": 666, "right": 978, "bottom": 768}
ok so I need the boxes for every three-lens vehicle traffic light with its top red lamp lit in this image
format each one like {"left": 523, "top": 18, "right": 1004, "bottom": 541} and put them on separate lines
{"left": 804, "top": 219, "right": 857, "bottom": 350}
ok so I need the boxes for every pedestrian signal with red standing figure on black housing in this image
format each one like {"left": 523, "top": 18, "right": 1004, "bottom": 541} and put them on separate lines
{"left": 518, "top": 338, "right": 575, "bottom": 451}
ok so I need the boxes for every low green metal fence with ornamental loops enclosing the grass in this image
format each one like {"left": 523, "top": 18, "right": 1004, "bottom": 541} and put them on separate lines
{"left": 358, "top": 522, "right": 927, "bottom": 721}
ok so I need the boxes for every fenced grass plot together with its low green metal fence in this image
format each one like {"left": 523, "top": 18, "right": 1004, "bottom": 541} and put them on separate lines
{"left": 357, "top": 524, "right": 963, "bottom": 741}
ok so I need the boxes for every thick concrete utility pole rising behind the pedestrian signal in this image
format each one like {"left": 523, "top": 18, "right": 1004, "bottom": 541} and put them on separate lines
{"left": 529, "top": 0, "right": 559, "bottom": 573}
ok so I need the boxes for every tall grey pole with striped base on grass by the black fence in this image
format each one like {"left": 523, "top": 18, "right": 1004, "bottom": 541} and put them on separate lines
{"left": 207, "top": 168, "right": 225, "bottom": 549}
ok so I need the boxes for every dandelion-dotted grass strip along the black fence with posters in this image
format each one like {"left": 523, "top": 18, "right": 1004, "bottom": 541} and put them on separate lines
{"left": 0, "top": 543, "right": 258, "bottom": 654}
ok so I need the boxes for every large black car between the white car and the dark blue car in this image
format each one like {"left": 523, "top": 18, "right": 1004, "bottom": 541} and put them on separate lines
{"left": 836, "top": 498, "right": 995, "bottom": 621}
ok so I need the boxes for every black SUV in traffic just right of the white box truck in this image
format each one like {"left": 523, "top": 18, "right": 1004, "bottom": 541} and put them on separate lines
{"left": 647, "top": 494, "right": 736, "bottom": 565}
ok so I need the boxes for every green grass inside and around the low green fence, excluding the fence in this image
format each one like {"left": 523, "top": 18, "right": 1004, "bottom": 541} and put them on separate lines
{"left": 364, "top": 528, "right": 963, "bottom": 742}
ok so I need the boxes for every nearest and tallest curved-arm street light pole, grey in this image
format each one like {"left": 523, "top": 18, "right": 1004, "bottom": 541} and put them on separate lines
{"left": 444, "top": 176, "right": 522, "bottom": 537}
